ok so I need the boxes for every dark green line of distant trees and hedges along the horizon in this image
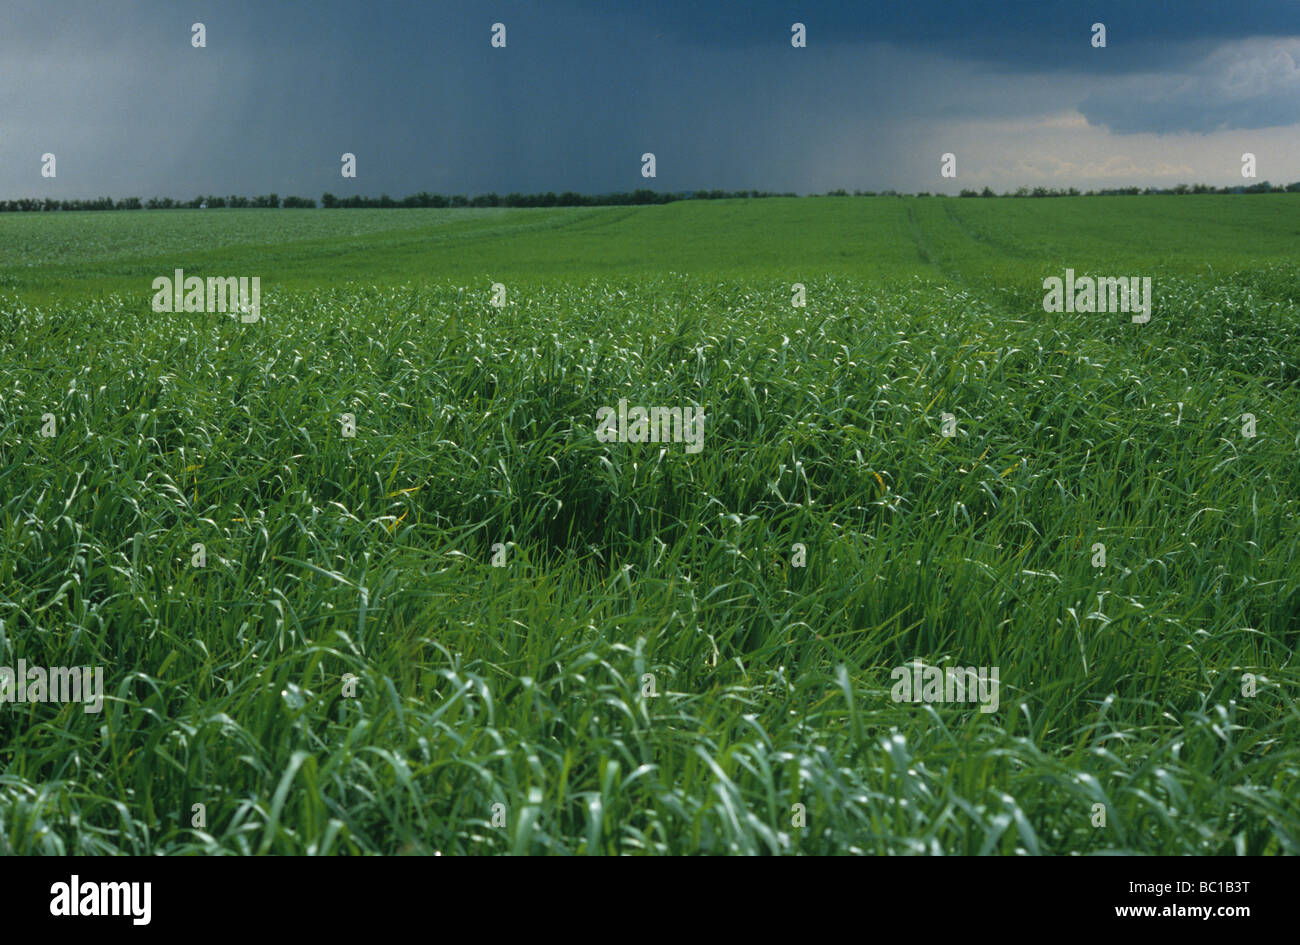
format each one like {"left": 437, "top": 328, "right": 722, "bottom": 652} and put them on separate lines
{"left": 0, "top": 181, "right": 1300, "bottom": 213}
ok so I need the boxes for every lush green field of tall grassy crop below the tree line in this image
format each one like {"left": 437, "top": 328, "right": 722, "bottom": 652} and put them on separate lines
{"left": 0, "top": 195, "right": 1300, "bottom": 854}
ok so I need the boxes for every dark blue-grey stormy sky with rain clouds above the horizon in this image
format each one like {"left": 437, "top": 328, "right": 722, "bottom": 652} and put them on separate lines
{"left": 0, "top": 0, "right": 1300, "bottom": 198}
